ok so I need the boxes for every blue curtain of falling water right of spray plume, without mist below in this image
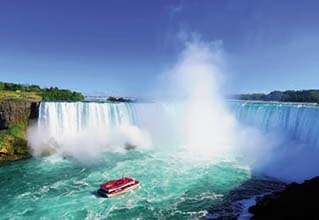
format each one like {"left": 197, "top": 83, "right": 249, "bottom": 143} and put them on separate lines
{"left": 231, "top": 102, "right": 319, "bottom": 149}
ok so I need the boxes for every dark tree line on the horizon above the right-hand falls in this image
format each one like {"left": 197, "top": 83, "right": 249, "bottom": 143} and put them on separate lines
{"left": 234, "top": 89, "right": 319, "bottom": 103}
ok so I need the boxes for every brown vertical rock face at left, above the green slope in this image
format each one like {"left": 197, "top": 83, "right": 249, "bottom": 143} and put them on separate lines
{"left": 0, "top": 99, "right": 39, "bottom": 130}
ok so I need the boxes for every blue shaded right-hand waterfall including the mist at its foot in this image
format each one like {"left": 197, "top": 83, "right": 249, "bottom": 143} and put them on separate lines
{"left": 230, "top": 102, "right": 319, "bottom": 181}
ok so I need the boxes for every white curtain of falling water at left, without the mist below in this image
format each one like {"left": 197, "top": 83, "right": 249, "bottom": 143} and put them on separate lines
{"left": 38, "top": 102, "right": 136, "bottom": 138}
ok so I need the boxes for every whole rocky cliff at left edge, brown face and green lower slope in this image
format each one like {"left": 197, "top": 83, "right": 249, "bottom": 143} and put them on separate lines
{"left": 0, "top": 99, "right": 40, "bottom": 161}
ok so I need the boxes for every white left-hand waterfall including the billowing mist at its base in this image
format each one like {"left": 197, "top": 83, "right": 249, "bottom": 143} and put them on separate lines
{"left": 28, "top": 102, "right": 150, "bottom": 160}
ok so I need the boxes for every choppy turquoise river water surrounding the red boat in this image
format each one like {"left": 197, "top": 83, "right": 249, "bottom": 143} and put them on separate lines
{"left": 0, "top": 149, "right": 251, "bottom": 219}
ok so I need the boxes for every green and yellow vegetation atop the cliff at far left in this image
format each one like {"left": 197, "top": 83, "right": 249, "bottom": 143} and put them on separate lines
{"left": 0, "top": 82, "right": 84, "bottom": 101}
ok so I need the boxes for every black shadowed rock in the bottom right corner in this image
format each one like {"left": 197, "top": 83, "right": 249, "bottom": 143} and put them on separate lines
{"left": 249, "top": 177, "right": 319, "bottom": 220}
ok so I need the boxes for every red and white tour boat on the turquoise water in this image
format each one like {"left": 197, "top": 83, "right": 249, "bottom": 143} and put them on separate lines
{"left": 97, "top": 177, "right": 140, "bottom": 198}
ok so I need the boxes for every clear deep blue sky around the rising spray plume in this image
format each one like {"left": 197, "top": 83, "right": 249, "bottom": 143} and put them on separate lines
{"left": 0, "top": 0, "right": 319, "bottom": 97}
